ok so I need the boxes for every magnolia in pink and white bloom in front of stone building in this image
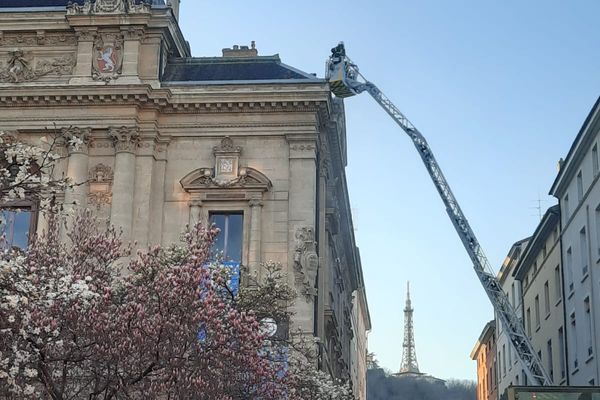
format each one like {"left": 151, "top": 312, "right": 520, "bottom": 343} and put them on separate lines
{"left": 0, "top": 135, "right": 352, "bottom": 400}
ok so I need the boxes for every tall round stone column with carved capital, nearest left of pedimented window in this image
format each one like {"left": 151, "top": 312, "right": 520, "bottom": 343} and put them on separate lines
{"left": 109, "top": 126, "right": 140, "bottom": 241}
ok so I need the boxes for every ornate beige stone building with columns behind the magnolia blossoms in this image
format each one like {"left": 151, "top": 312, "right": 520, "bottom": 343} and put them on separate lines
{"left": 0, "top": 0, "right": 370, "bottom": 399}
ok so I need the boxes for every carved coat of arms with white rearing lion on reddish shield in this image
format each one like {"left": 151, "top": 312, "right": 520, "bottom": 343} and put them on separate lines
{"left": 92, "top": 35, "right": 123, "bottom": 81}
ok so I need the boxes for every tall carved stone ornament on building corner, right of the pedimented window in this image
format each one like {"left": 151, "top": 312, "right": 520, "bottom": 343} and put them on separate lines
{"left": 294, "top": 227, "right": 319, "bottom": 301}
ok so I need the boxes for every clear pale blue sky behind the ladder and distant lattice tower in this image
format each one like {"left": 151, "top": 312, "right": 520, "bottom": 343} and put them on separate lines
{"left": 181, "top": 0, "right": 600, "bottom": 379}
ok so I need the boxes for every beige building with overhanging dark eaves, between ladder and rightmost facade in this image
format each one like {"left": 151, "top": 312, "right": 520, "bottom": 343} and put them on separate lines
{"left": 513, "top": 206, "right": 569, "bottom": 386}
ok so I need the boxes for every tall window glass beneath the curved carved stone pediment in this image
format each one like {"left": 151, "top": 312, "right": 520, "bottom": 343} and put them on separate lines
{"left": 210, "top": 213, "right": 244, "bottom": 263}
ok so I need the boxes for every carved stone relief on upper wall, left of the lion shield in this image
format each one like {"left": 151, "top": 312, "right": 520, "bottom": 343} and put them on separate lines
{"left": 0, "top": 50, "right": 76, "bottom": 83}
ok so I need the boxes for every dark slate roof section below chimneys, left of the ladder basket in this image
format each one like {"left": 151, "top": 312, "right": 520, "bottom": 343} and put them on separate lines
{"left": 162, "top": 55, "right": 318, "bottom": 84}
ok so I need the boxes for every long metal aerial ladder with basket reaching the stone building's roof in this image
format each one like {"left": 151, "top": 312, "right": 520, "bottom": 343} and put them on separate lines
{"left": 326, "top": 42, "right": 552, "bottom": 386}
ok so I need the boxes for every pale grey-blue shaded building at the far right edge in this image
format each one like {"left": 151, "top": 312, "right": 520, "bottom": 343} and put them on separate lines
{"left": 550, "top": 98, "right": 600, "bottom": 386}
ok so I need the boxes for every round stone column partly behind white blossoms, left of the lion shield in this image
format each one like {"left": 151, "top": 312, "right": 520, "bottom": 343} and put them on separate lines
{"left": 62, "top": 128, "right": 91, "bottom": 209}
